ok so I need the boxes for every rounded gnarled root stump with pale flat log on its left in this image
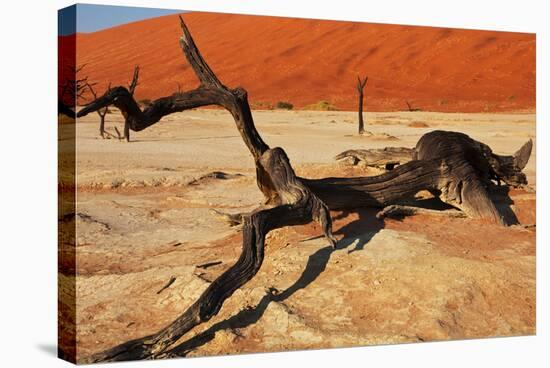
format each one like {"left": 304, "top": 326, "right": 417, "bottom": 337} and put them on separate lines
{"left": 334, "top": 130, "right": 533, "bottom": 224}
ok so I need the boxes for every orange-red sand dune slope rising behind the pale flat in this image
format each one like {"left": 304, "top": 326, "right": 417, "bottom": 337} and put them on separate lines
{"left": 72, "top": 13, "right": 535, "bottom": 112}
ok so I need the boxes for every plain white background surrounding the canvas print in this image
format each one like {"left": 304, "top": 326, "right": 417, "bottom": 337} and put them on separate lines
{"left": 0, "top": 0, "right": 550, "bottom": 368}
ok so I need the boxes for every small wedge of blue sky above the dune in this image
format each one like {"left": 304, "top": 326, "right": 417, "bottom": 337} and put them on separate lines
{"left": 58, "top": 4, "right": 183, "bottom": 35}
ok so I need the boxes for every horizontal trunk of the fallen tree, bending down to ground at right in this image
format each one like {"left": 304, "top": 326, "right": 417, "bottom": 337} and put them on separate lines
{"left": 308, "top": 159, "right": 505, "bottom": 225}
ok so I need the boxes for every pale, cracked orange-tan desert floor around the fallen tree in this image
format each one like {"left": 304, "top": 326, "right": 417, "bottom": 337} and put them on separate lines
{"left": 62, "top": 110, "right": 536, "bottom": 358}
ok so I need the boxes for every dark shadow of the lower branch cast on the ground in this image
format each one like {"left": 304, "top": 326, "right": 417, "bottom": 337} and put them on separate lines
{"left": 167, "top": 209, "right": 384, "bottom": 357}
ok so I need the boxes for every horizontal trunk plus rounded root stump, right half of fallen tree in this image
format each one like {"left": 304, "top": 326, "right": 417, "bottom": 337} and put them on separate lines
{"left": 330, "top": 130, "right": 533, "bottom": 224}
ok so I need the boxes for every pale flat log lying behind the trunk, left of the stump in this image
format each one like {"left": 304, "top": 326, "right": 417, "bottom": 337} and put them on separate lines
{"left": 335, "top": 147, "right": 414, "bottom": 170}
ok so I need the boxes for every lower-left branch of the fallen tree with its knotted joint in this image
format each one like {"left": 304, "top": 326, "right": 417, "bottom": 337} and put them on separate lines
{"left": 84, "top": 148, "right": 336, "bottom": 363}
